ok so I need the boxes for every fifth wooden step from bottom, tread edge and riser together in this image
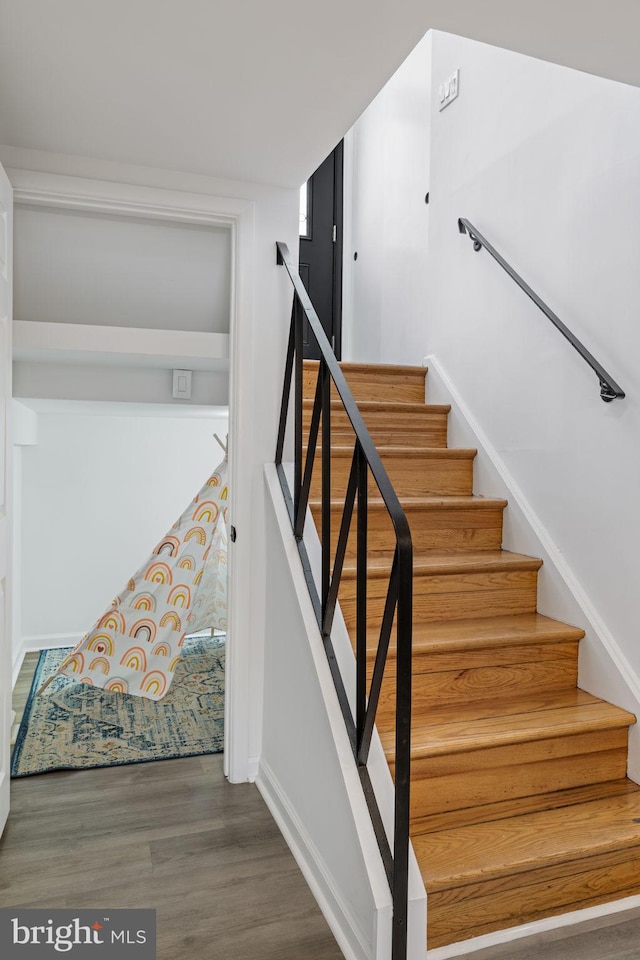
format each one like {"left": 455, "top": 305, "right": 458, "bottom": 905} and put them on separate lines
{"left": 309, "top": 496, "right": 507, "bottom": 558}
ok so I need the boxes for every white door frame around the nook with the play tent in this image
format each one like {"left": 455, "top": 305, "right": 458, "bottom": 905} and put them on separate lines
{"left": 7, "top": 169, "right": 257, "bottom": 783}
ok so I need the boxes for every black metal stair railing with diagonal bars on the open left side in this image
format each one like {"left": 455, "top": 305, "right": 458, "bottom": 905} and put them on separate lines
{"left": 275, "top": 242, "right": 413, "bottom": 960}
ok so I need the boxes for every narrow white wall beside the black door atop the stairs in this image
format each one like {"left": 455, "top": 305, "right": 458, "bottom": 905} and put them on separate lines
{"left": 344, "top": 34, "right": 431, "bottom": 363}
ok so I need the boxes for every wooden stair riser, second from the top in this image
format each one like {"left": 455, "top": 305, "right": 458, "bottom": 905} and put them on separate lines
{"left": 302, "top": 407, "right": 447, "bottom": 447}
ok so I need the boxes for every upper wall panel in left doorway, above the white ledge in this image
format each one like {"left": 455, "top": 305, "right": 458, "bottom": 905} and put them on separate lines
{"left": 14, "top": 204, "right": 231, "bottom": 333}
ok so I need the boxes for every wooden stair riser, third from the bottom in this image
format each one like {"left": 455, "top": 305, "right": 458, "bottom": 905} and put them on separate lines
{"left": 377, "top": 643, "right": 578, "bottom": 729}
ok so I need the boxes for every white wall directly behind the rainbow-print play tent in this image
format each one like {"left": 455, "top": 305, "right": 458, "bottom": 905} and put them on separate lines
{"left": 20, "top": 404, "right": 228, "bottom": 649}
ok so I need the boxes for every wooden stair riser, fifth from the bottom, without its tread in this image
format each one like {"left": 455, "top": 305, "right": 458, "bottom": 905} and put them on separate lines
{"left": 312, "top": 505, "right": 502, "bottom": 558}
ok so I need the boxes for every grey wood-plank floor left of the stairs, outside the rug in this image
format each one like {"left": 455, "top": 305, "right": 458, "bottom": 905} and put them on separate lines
{"left": 5, "top": 662, "right": 342, "bottom": 960}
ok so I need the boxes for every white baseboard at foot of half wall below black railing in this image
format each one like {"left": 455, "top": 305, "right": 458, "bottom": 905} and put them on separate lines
{"left": 256, "top": 760, "right": 370, "bottom": 960}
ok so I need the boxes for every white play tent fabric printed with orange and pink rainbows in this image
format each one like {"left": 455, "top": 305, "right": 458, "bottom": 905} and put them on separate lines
{"left": 57, "top": 458, "right": 229, "bottom": 700}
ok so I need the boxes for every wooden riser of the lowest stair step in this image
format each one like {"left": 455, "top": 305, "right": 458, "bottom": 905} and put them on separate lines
{"left": 427, "top": 848, "right": 640, "bottom": 949}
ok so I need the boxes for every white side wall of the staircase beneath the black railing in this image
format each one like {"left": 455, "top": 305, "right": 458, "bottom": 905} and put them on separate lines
{"left": 256, "top": 464, "right": 426, "bottom": 960}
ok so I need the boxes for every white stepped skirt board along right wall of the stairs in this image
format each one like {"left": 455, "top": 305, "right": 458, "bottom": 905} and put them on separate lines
{"left": 423, "top": 355, "right": 640, "bottom": 783}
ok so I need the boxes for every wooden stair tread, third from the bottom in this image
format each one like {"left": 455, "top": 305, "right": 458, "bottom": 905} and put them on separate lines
{"left": 367, "top": 613, "right": 584, "bottom": 657}
